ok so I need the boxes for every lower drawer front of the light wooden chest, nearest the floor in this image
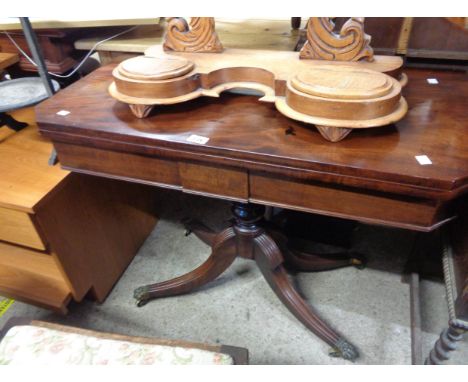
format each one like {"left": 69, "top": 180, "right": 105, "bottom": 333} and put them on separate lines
{"left": 0, "top": 242, "right": 71, "bottom": 313}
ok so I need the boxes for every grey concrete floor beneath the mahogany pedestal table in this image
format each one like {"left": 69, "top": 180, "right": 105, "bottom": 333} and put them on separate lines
{"left": 0, "top": 190, "right": 468, "bottom": 365}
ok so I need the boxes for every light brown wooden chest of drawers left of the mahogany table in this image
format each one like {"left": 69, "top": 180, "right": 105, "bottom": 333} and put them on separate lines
{"left": 0, "top": 109, "right": 156, "bottom": 313}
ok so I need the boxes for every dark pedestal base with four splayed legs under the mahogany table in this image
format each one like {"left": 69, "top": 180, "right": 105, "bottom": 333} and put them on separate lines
{"left": 134, "top": 203, "right": 363, "bottom": 360}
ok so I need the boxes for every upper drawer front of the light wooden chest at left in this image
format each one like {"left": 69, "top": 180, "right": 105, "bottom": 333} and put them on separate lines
{"left": 0, "top": 208, "right": 46, "bottom": 251}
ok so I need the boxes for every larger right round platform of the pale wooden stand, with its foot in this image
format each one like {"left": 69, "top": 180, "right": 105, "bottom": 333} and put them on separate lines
{"left": 275, "top": 66, "right": 408, "bottom": 142}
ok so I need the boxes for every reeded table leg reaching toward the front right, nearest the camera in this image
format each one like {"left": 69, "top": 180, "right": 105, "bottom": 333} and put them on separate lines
{"left": 254, "top": 233, "right": 359, "bottom": 361}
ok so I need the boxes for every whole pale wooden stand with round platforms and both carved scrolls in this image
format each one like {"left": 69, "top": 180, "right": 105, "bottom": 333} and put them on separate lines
{"left": 109, "top": 18, "right": 408, "bottom": 142}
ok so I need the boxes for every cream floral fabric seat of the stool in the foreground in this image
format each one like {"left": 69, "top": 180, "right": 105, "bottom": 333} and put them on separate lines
{"left": 0, "top": 325, "right": 234, "bottom": 366}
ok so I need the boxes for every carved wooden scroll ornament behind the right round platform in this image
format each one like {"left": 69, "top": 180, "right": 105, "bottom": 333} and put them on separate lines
{"left": 299, "top": 17, "right": 374, "bottom": 61}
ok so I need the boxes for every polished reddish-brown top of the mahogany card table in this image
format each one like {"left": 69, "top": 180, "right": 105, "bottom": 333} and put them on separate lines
{"left": 36, "top": 66, "right": 468, "bottom": 192}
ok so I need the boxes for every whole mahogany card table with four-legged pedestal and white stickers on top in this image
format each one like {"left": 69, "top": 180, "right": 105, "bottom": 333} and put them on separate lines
{"left": 36, "top": 65, "right": 468, "bottom": 360}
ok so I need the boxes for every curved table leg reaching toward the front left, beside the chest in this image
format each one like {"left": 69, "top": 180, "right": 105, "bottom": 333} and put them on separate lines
{"left": 134, "top": 228, "right": 237, "bottom": 306}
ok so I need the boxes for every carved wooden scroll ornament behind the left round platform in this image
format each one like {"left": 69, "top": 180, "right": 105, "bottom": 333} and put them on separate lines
{"left": 163, "top": 17, "right": 223, "bottom": 53}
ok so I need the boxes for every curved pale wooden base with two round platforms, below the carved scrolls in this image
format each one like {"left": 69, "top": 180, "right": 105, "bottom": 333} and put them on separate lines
{"left": 109, "top": 48, "right": 407, "bottom": 142}
